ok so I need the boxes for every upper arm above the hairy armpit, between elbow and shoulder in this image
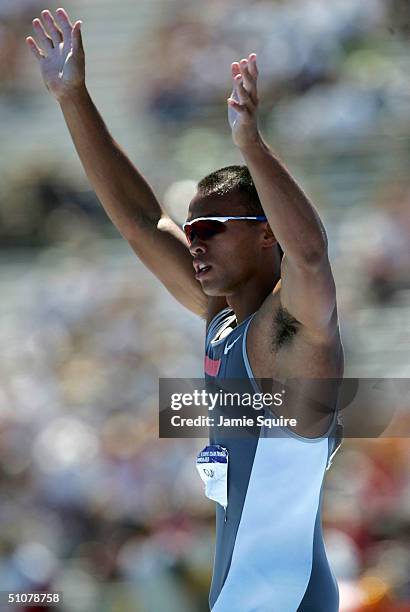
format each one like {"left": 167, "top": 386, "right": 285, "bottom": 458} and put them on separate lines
{"left": 280, "top": 251, "right": 337, "bottom": 337}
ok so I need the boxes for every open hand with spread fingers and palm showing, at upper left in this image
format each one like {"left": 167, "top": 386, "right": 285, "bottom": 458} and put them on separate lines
{"left": 26, "top": 8, "right": 85, "bottom": 99}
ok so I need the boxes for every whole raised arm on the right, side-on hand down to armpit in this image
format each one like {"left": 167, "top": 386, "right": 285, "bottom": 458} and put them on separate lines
{"left": 227, "top": 53, "right": 337, "bottom": 340}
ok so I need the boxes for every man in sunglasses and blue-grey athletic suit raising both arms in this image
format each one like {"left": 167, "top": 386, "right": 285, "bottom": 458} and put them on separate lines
{"left": 27, "top": 9, "right": 344, "bottom": 612}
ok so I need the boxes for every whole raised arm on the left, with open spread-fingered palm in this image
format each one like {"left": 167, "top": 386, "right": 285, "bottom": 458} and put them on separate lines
{"left": 26, "top": 9, "right": 221, "bottom": 318}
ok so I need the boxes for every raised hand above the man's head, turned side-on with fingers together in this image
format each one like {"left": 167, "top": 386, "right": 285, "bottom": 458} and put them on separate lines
{"left": 227, "top": 53, "right": 259, "bottom": 147}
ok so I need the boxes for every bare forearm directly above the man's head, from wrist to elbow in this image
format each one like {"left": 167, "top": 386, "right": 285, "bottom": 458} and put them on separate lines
{"left": 240, "top": 137, "right": 327, "bottom": 263}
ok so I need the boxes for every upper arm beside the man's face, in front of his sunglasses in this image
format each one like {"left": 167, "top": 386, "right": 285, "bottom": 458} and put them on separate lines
{"left": 127, "top": 213, "right": 210, "bottom": 319}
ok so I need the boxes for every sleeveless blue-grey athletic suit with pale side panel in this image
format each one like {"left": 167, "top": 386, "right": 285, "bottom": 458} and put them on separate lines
{"left": 204, "top": 308, "right": 341, "bottom": 612}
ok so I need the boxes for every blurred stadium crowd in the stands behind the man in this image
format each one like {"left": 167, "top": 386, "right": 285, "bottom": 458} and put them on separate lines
{"left": 0, "top": 0, "right": 410, "bottom": 612}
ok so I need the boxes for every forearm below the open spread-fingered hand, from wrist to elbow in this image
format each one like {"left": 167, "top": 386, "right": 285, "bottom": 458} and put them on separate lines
{"left": 59, "top": 88, "right": 162, "bottom": 238}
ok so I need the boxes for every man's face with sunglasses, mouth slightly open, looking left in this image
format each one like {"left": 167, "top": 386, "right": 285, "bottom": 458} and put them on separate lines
{"left": 187, "top": 194, "right": 274, "bottom": 295}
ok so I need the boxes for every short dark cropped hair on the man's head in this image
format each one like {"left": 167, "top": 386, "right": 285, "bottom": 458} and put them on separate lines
{"left": 197, "top": 166, "right": 283, "bottom": 260}
